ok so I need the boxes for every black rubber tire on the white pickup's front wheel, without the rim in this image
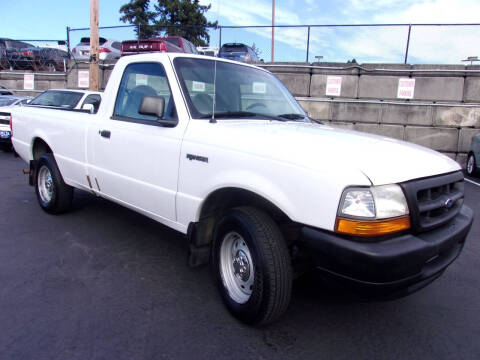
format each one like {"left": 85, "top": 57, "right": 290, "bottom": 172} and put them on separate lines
{"left": 211, "top": 207, "right": 292, "bottom": 325}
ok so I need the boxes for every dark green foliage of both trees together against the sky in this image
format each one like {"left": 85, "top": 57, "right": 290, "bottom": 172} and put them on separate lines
{"left": 120, "top": 0, "right": 217, "bottom": 46}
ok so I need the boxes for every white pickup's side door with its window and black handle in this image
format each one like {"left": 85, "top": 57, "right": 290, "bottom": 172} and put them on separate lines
{"left": 89, "top": 62, "right": 186, "bottom": 221}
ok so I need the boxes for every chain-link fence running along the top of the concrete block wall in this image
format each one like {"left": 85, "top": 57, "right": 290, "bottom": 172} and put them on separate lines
{"left": 0, "top": 23, "right": 480, "bottom": 71}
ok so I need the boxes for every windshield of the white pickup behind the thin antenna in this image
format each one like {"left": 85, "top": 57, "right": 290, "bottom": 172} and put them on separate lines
{"left": 174, "top": 57, "right": 306, "bottom": 120}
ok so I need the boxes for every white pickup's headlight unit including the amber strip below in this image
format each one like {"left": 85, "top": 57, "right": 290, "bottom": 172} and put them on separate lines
{"left": 335, "top": 184, "right": 410, "bottom": 236}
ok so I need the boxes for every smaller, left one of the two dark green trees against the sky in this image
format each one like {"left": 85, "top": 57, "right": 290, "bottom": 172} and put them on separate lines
{"left": 120, "top": 0, "right": 157, "bottom": 39}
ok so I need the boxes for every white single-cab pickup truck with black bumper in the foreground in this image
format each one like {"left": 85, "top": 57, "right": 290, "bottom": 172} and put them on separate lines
{"left": 11, "top": 53, "right": 473, "bottom": 324}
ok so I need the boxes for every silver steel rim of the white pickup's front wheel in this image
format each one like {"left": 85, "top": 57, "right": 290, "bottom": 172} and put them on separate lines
{"left": 219, "top": 232, "right": 255, "bottom": 304}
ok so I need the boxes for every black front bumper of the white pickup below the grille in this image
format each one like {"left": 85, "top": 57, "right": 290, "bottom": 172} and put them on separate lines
{"left": 302, "top": 205, "right": 473, "bottom": 296}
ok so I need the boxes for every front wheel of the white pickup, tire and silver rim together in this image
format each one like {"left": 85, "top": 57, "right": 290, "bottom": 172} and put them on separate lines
{"left": 212, "top": 207, "right": 292, "bottom": 324}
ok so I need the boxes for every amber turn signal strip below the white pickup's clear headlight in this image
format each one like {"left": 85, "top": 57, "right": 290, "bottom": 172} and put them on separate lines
{"left": 335, "top": 216, "right": 410, "bottom": 236}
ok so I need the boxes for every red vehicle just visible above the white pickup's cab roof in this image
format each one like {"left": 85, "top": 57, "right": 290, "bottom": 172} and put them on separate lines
{"left": 121, "top": 36, "right": 198, "bottom": 55}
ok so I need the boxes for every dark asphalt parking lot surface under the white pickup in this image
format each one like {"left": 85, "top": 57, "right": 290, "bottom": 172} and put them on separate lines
{"left": 0, "top": 151, "right": 480, "bottom": 360}
